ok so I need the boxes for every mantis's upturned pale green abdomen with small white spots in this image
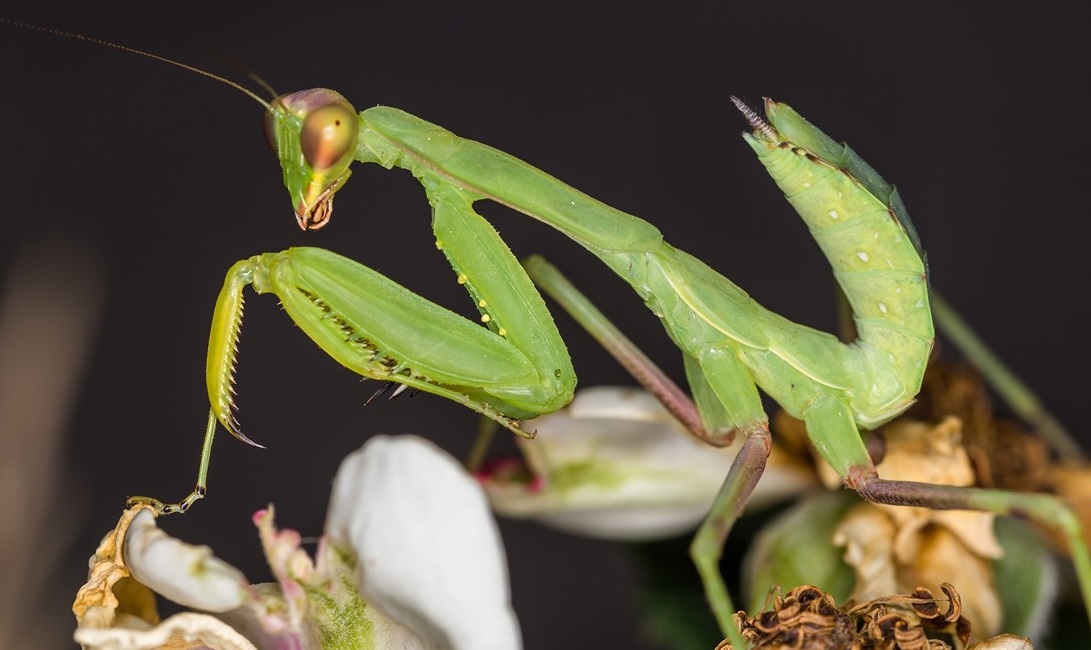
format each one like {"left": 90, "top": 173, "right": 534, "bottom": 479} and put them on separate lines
{"left": 745, "top": 103, "right": 934, "bottom": 410}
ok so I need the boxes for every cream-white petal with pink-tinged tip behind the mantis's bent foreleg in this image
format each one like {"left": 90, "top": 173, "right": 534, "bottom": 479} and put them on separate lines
{"left": 479, "top": 386, "right": 817, "bottom": 541}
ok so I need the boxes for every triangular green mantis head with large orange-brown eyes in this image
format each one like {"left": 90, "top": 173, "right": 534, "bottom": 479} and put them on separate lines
{"left": 265, "top": 88, "right": 359, "bottom": 230}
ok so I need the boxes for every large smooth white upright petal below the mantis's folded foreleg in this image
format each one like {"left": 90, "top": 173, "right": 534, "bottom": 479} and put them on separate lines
{"left": 326, "top": 436, "right": 521, "bottom": 650}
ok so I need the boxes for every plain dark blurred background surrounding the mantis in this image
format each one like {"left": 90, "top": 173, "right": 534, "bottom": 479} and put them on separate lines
{"left": 0, "top": 1, "right": 1091, "bottom": 650}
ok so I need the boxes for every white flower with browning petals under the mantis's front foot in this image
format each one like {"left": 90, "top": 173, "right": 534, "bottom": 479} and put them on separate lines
{"left": 72, "top": 436, "right": 521, "bottom": 650}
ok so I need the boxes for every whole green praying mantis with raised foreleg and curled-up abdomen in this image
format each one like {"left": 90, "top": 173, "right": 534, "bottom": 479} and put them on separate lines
{"left": 6, "top": 19, "right": 1091, "bottom": 648}
